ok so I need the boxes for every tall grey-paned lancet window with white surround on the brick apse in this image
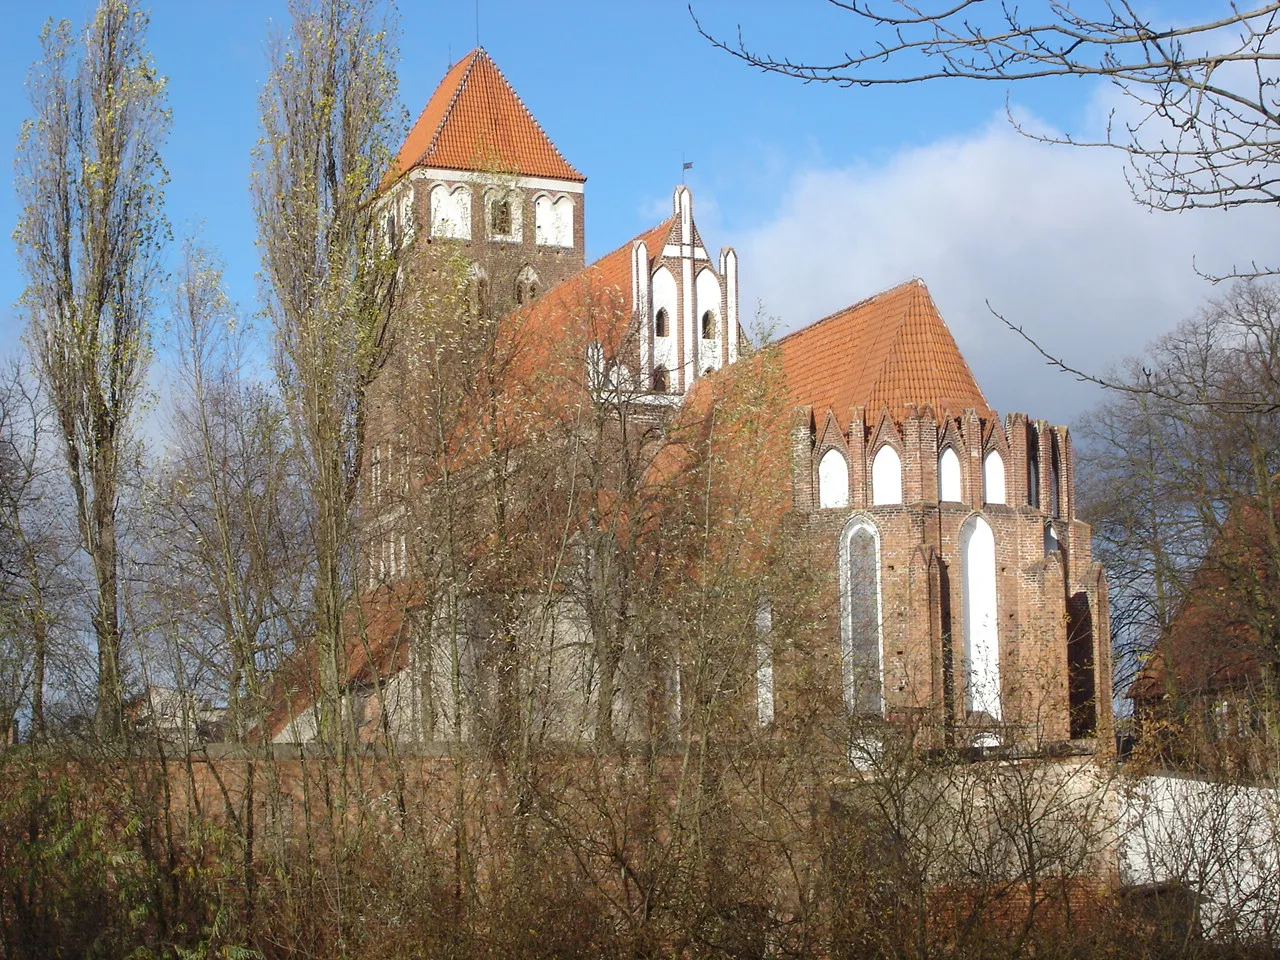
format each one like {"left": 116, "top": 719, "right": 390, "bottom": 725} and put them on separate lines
{"left": 840, "top": 520, "right": 884, "bottom": 714}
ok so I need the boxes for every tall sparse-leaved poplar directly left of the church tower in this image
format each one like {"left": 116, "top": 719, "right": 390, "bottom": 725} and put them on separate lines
{"left": 252, "top": 0, "right": 401, "bottom": 739}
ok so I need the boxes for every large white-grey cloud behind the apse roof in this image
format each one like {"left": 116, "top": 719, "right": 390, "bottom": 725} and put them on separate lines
{"left": 737, "top": 118, "right": 1280, "bottom": 422}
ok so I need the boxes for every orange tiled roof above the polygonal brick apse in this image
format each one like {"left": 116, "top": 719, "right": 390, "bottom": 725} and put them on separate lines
{"left": 778, "top": 279, "right": 995, "bottom": 424}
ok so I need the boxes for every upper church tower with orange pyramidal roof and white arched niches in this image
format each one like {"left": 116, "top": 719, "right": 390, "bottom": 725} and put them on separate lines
{"left": 383, "top": 47, "right": 586, "bottom": 303}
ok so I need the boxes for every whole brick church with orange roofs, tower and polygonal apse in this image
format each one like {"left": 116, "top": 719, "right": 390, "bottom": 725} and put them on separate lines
{"left": 270, "top": 50, "right": 1112, "bottom": 751}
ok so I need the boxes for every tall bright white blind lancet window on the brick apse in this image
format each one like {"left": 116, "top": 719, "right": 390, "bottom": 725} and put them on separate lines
{"left": 960, "top": 516, "right": 1000, "bottom": 719}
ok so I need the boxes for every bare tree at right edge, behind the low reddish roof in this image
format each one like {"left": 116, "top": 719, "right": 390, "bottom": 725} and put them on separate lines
{"left": 1080, "top": 282, "right": 1280, "bottom": 694}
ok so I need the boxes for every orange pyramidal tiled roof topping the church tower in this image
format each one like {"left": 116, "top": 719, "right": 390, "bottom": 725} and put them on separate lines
{"left": 383, "top": 47, "right": 586, "bottom": 187}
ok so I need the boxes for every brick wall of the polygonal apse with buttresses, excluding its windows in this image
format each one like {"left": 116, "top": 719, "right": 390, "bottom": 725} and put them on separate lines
{"left": 791, "top": 407, "right": 1112, "bottom": 750}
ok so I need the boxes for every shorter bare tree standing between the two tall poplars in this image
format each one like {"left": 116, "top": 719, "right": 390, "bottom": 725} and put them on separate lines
{"left": 143, "top": 242, "right": 312, "bottom": 739}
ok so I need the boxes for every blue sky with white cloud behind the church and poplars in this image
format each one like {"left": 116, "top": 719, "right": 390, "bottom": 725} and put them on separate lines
{"left": 0, "top": 0, "right": 1280, "bottom": 421}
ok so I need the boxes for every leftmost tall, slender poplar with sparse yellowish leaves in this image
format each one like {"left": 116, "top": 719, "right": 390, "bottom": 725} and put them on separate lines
{"left": 15, "top": 0, "right": 169, "bottom": 739}
